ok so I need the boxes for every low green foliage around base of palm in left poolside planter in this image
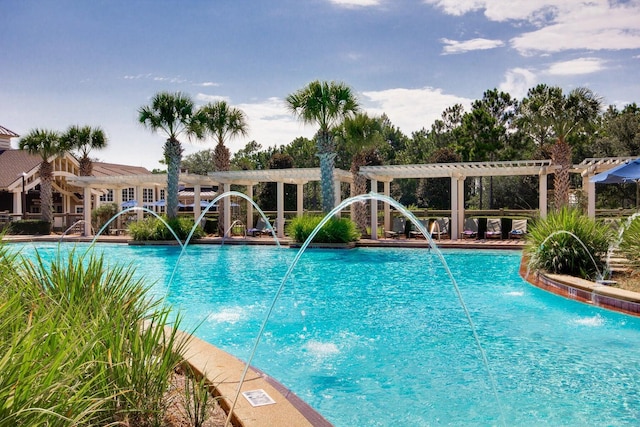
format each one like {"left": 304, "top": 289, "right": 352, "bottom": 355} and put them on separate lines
{"left": 128, "top": 216, "right": 204, "bottom": 241}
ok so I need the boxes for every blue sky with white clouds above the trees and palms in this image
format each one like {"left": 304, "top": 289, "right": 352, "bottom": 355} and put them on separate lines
{"left": 0, "top": 0, "right": 640, "bottom": 169}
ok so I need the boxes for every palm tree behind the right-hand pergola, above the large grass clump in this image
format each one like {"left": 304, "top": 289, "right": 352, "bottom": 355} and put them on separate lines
{"left": 520, "top": 84, "right": 602, "bottom": 209}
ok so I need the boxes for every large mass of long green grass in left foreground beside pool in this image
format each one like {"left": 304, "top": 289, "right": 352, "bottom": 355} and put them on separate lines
{"left": 0, "top": 245, "right": 186, "bottom": 426}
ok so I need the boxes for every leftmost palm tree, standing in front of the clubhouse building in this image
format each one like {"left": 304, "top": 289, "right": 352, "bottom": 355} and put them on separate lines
{"left": 19, "top": 129, "right": 69, "bottom": 223}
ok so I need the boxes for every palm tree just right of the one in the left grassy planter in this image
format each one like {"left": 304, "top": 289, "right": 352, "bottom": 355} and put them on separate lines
{"left": 198, "top": 101, "right": 249, "bottom": 236}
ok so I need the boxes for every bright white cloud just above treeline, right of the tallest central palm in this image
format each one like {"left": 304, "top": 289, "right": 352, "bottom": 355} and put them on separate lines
{"left": 362, "top": 87, "right": 472, "bottom": 135}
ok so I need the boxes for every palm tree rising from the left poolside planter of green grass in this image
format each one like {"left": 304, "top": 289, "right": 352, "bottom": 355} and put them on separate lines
{"left": 138, "top": 92, "right": 202, "bottom": 219}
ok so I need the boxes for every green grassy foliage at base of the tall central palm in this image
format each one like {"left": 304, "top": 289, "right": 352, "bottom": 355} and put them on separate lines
{"left": 287, "top": 216, "right": 360, "bottom": 243}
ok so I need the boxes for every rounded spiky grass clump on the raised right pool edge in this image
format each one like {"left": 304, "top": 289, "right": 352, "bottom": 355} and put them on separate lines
{"left": 525, "top": 208, "right": 613, "bottom": 280}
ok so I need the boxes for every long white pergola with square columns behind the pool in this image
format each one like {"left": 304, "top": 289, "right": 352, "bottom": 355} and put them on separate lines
{"left": 67, "top": 157, "right": 635, "bottom": 240}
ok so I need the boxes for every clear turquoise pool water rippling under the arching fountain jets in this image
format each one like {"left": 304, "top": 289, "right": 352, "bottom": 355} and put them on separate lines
{"left": 8, "top": 244, "right": 640, "bottom": 426}
